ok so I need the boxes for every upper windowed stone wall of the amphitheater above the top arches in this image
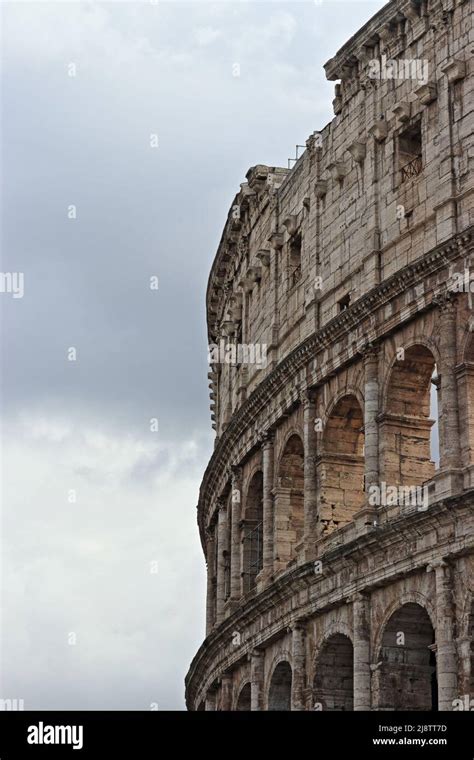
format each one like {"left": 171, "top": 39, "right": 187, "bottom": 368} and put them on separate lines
{"left": 207, "top": 0, "right": 474, "bottom": 436}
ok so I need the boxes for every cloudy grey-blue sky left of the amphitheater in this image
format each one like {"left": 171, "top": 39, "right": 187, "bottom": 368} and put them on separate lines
{"left": 0, "top": 0, "right": 384, "bottom": 710}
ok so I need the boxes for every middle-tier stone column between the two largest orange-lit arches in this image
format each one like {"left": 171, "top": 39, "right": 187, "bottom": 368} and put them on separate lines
{"left": 364, "top": 346, "right": 380, "bottom": 494}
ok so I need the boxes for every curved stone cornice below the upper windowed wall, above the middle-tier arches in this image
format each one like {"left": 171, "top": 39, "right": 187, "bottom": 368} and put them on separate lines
{"left": 198, "top": 227, "right": 473, "bottom": 545}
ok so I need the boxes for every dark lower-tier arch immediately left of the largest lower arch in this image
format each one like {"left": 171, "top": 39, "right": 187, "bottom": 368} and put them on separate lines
{"left": 313, "top": 633, "right": 354, "bottom": 712}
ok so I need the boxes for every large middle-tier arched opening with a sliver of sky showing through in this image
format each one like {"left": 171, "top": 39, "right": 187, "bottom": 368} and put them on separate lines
{"left": 381, "top": 345, "right": 439, "bottom": 486}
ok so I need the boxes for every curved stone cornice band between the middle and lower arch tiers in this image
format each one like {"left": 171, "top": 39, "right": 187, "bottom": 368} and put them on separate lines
{"left": 186, "top": 496, "right": 474, "bottom": 707}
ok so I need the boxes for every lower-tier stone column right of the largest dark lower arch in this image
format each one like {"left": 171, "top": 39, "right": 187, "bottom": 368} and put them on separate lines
{"left": 428, "top": 560, "right": 458, "bottom": 710}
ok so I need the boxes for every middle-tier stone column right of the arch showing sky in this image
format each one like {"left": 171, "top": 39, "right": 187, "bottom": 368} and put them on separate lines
{"left": 438, "top": 294, "right": 461, "bottom": 469}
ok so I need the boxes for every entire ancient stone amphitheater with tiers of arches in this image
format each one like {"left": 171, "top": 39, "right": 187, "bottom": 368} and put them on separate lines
{"left": 186, "top": 0, "right": 474, "bottom": 710}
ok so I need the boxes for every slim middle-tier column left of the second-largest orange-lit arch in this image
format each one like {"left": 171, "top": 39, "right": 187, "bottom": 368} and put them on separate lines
{"left": 303, "top": 390, "right": 318, "bottom": 560}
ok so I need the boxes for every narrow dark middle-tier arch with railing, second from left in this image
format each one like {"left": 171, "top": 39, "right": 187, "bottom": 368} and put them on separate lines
{"left": 242, "top": 471, "right": 263, "bottom": 594}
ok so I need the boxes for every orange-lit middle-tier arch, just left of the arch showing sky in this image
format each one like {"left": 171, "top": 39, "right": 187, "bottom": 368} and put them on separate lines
{"left": 318, "top": 394, "right": 365, "bottom": 535}
